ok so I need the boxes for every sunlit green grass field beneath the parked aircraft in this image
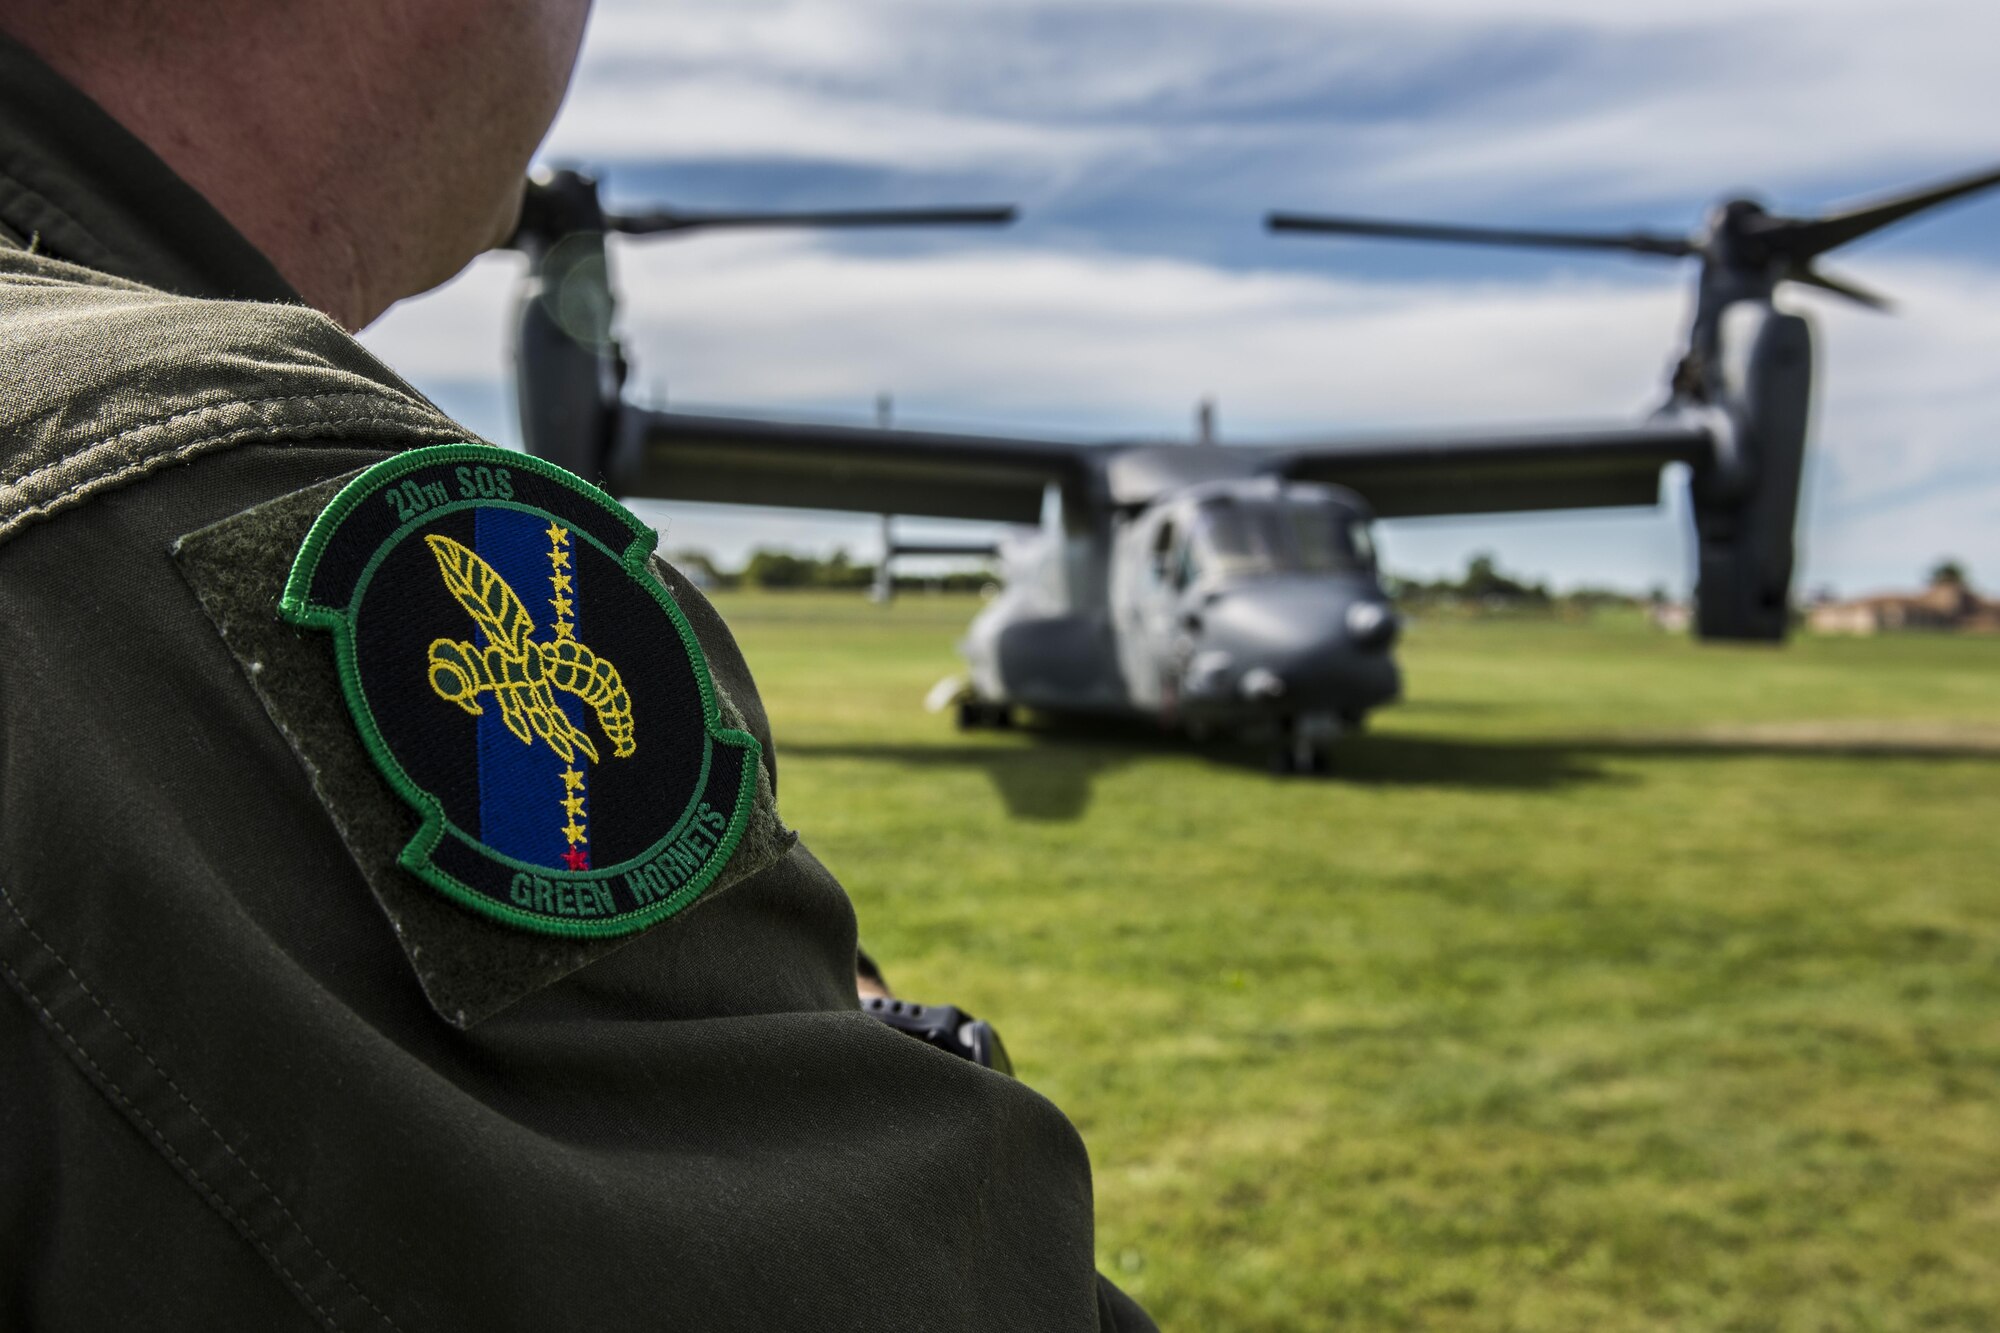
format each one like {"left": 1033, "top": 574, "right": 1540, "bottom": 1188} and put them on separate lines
{"left": 720, "top": 594, "right": 2000, "bottom": 1331}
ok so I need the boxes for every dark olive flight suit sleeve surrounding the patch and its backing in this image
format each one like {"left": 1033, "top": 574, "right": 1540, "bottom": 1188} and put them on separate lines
{"left": 0, "top": 440, "right": 1150, "bottom": 1331}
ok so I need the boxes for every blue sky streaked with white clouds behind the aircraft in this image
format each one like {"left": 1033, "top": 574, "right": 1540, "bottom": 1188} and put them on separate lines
{"left": 362, "top": 0, "right": 2000, "bottom": 594}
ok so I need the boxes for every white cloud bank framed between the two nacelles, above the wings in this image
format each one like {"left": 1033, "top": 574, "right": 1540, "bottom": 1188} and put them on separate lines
{"left": 608, "top": 240, "right": 1678, "bottom": 432}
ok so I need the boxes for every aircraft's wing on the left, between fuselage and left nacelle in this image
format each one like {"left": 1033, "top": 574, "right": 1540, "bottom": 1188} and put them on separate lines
{"left": 618, "top": 408, "right": 1098, "bottom": 524}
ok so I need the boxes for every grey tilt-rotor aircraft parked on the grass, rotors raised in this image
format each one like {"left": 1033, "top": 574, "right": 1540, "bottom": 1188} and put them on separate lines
{"left": 514, "top": 170, "right": 2000, "bottom": 771}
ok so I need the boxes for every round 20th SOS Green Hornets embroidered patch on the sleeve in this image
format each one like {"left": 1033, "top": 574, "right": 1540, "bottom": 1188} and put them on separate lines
{"left": 290, "top": 444, "right": 758, "bottom": 935}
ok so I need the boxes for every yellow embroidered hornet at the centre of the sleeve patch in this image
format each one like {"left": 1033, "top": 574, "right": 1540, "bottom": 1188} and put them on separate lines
{"left": 424, "top": 534, "right": 638, "bottom": 763}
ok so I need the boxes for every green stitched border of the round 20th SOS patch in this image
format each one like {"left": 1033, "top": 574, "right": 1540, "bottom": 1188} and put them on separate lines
{"left": 278, "top": 442, "right": 764, "bottom": 939}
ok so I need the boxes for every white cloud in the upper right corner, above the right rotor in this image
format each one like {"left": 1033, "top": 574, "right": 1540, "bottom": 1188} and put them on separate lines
{"left": 1344, "top": 0, "right": 2000, "bottom": 202}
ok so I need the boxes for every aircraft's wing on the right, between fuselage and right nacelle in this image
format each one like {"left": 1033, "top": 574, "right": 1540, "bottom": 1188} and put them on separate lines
{"left": 1260, "top": 424, "right": 1716, "bottom": 518}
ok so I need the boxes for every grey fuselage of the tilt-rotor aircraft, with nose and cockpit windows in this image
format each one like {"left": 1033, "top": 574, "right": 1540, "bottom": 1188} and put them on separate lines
{"left": 962, "top": 478, "right": 1400, "bottom": 755}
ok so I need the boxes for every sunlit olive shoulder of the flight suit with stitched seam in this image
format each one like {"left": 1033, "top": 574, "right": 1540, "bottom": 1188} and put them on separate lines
{"left": 0, "top": 248, "right": 472, "bottom": 542}
